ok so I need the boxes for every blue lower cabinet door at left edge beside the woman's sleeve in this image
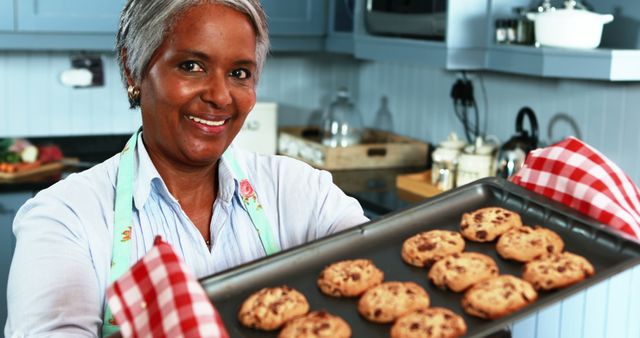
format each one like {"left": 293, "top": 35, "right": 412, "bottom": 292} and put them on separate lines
{"left": 0, "top": 192, "right": 32, "bottom": 332}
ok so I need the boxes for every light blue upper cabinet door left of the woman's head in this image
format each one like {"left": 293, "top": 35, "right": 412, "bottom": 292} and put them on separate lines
{"left": 16, "top": 0, "right": 124, "bottom": 33}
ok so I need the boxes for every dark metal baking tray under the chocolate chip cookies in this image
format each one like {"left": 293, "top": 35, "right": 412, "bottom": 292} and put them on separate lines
{"left": 201, "top": 178, "right": 640, "bottom": 337}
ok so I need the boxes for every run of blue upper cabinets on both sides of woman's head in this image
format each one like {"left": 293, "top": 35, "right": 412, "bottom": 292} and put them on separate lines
{"left": 0, "top": 0, "right": 328, "bottom": 52}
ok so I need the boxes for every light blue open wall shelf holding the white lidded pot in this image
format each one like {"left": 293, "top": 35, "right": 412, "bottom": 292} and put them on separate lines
{"left": 487, "top": 0, "right": 640, "bottom": 81}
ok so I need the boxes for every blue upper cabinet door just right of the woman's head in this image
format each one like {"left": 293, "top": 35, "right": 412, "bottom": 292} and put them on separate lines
{"left": 262, "top": 0, "right": 327, "bottom": 36}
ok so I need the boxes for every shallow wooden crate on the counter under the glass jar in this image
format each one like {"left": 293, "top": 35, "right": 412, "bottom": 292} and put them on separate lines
{"left": 278, "top": 127, "right": 428, "bottom": 170}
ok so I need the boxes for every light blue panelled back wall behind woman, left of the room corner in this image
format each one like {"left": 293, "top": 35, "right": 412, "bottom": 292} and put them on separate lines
{"left": 0, "top": 51, "right": 358, "bottom": 137}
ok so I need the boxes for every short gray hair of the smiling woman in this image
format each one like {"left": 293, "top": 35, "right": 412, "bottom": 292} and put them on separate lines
{"left": 116, "top": 0, "right": 269, "bottom": 104}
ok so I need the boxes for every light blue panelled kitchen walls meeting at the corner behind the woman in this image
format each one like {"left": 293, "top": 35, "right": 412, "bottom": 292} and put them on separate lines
{"left": 0, "top": 52, "right": 640, "bottom": 182}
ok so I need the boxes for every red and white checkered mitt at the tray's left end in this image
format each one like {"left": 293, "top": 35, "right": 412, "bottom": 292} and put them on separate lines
{"left": 107, "top": 236, "right": 229, "bottom": 338}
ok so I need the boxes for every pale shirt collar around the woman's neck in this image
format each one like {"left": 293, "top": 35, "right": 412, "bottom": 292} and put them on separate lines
{"left": 133, "top": 133, "right": 240, "bottom": 210}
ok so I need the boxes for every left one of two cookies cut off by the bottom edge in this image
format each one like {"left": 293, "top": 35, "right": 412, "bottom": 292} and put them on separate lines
{"left": 278, "top": 311, "right": 351, "bottom": 338}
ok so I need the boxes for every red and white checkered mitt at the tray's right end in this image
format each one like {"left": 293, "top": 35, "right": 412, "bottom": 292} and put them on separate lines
{"left": 512, "top": 137, "right": 640, "bottom": 239}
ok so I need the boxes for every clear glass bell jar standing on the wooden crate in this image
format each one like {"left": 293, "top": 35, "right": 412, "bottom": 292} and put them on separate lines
{"left": 321, "top": 87, "right": 363, "bottom": 148}
